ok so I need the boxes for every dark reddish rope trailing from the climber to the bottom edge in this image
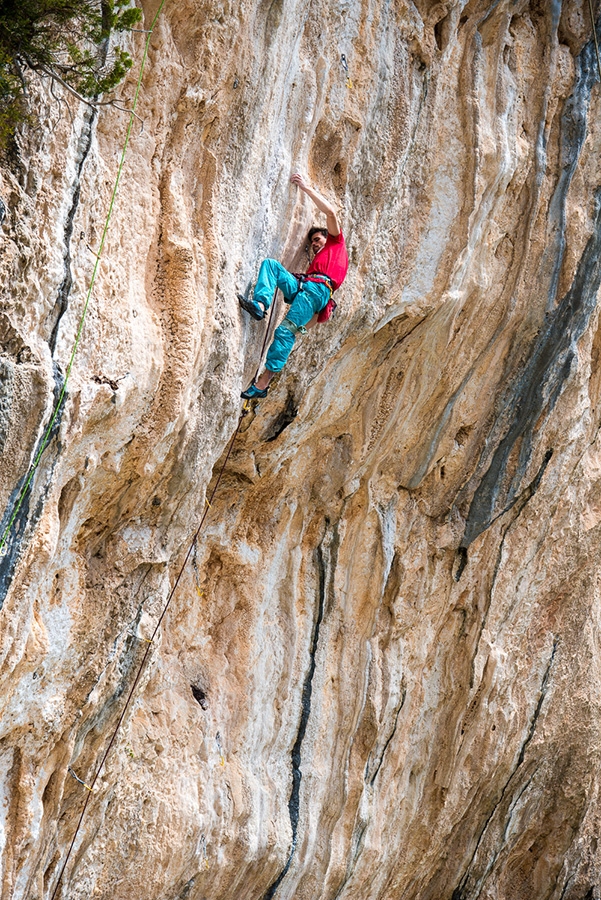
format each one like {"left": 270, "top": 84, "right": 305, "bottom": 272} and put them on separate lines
{"left": 50, "top": 292, "right": 277, "bottom": 900}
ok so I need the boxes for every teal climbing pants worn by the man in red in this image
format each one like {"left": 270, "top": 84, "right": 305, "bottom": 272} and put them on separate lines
{"left": 253, "top": 259, "right": 330, "bottom": 372}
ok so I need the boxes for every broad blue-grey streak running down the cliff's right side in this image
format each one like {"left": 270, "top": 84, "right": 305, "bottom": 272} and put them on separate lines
{"left": 461, "top": 21, "right": 601, "bottom": 558}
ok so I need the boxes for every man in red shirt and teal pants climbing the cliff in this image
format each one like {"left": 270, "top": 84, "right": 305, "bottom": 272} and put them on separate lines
{"left": 238, "top": 175, "right": 348, "bottom": 400}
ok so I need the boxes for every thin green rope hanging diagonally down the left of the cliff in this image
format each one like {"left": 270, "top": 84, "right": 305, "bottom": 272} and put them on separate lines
{"left": 0, "top": 0, "right": 165, "bottom": 555}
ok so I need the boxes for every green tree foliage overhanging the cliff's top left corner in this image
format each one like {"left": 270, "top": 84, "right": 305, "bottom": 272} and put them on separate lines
{"left": 0, "top": 0, "right": 141, "bottom": 145}
